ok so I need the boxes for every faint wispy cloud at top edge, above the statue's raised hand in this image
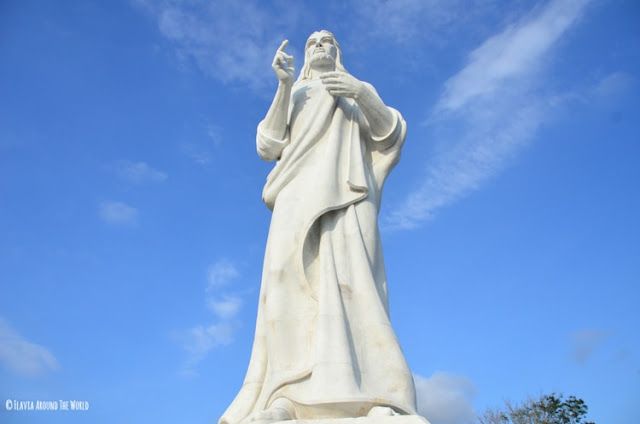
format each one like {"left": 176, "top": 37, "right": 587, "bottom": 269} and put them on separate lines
{"left": 136, "top": 0, "right": 302, "bottom": 90}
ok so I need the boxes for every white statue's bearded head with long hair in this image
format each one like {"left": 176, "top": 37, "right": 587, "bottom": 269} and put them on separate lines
{"left": 298, "top": 29, "right": 347, "bottom": 81}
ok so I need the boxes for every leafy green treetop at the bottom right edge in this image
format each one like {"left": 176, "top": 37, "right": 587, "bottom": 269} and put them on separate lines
{"left": 479, "top": 393, "right": 595, "bottom": 424}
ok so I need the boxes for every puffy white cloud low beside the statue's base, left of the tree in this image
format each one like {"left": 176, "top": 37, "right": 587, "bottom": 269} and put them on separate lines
{"left": 413, "top": 372, "right": 477, "bottom": 424}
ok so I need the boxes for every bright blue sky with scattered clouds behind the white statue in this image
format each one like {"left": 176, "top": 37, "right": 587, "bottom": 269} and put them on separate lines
{"left": 0, "top": 0, "right": 640, "bottom": 424}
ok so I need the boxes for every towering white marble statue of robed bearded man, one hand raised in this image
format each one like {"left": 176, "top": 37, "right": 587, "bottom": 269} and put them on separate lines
{"left": 220, "top": 30, "right": 424, "bottom": 424}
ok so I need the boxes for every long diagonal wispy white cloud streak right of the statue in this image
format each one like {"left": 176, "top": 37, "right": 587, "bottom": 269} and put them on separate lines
{"left": 385, "top": 0, "right": 589, "bottom": 228}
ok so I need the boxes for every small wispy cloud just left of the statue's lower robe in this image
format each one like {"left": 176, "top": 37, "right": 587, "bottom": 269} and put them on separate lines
{"left": 178, "top": 259, "right": 243, "bottom": 377}
